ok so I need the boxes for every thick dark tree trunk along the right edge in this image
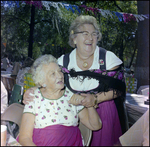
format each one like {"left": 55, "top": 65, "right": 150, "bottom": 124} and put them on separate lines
{"left": 135, "top": 1, "right": 149, "bottom": 88}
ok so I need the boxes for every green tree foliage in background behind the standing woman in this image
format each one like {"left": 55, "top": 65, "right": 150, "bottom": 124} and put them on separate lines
{"left": 1, "top": 1, "right": 137, "bottom": 65}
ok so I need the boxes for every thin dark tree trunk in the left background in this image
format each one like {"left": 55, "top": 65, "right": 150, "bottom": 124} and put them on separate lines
{"left": 28, "top": 5, "right": 35, "bottom": 58}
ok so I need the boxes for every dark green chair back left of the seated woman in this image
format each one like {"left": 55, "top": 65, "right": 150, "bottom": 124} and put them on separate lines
{"left": 8, "top": 84, "right": 23, "bottom": 105}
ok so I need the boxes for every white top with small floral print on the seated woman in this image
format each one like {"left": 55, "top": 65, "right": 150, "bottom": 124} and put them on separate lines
{"left": 24, "top": 88, "right": 84, "bottom": 128}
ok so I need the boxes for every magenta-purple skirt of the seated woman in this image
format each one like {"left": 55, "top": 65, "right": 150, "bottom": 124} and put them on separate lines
{"left": 17, "top": 125, "right": 83, "bottom": 146}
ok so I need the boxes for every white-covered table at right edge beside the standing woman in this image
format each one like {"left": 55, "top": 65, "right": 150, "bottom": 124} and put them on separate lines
{"left": 125, "top": 93, "right": 149, "bottom": 125}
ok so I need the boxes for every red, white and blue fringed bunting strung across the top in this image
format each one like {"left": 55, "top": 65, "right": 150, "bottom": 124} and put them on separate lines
{"left": 1, "top": 1, "right": 149, "bottom": 23}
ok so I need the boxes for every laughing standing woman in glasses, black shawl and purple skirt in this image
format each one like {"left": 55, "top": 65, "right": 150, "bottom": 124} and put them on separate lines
{"left": 24, "top": 15, "right": 126, "bottom": 146}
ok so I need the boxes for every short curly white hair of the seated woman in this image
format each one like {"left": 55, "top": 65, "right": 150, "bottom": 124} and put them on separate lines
{"left": 31, "top": 54, "right": 57, "bottom": 87}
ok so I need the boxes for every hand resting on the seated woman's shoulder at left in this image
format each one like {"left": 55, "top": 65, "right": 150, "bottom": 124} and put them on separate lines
{"left": 23, "top": 87, "right": 37, "bottom": 104}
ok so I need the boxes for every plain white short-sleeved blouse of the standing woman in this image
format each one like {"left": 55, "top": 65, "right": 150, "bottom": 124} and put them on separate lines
{"left": 58, "top": 46, "right": 122, "bottom": 91}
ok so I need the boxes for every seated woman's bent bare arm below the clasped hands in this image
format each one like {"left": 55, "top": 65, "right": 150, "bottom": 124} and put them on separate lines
{"left": 79, "top": 107, "right": 102, "bottom": 130}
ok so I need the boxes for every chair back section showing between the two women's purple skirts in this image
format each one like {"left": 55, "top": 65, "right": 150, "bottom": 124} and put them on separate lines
{"left": 79, "top": 122, "right": 92, "bottom": 146}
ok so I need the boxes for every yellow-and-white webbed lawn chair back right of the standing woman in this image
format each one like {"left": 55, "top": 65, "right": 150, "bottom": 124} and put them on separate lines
{"left": 125, "top": 77, "right": 137, "bottom": 93}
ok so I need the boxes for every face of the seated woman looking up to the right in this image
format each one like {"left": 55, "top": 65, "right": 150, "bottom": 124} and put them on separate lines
{"left": 42, "top": 63, "right": 64, "bottom": 91}
